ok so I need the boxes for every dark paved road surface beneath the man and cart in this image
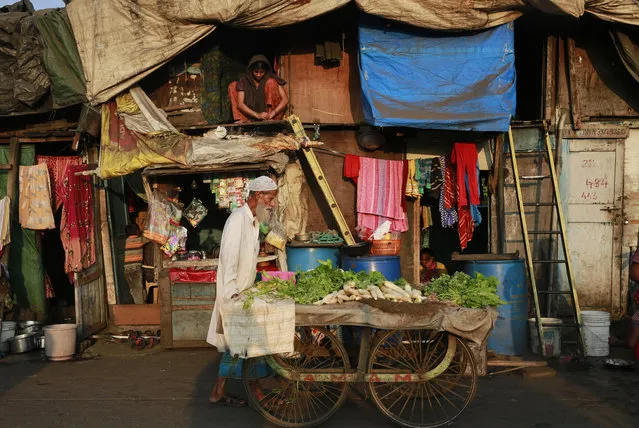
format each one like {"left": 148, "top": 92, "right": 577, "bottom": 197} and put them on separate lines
{"left": 0, "top": 344, "right": 639, "bottom": 428}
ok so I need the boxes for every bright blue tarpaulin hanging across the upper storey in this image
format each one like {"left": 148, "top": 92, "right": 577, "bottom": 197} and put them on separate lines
{"left": 359, "top": 17, "right": 515, "bottom": 131}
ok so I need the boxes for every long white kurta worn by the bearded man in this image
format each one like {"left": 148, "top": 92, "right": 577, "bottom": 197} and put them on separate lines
{"left": 206, "top": 204, "right": 260, "bottom": 352}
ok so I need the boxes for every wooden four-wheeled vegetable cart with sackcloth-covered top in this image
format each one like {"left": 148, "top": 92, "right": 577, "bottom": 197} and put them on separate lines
{"left": 243, "top": 302, "right": 496, "bottom": 427}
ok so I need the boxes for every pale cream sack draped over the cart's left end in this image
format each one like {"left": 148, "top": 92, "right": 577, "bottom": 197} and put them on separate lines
{"left": 220, "top": 297, "right": 295, "bottom": 358}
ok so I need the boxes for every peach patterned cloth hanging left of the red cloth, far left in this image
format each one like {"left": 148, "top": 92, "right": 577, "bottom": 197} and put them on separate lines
{"left": 19, "top": 165, "right": 55, "bottom": 230}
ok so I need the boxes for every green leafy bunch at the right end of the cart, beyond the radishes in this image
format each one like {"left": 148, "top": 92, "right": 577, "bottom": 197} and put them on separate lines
{"left": 424, "top": 272, "right": 506, "bottom": 308}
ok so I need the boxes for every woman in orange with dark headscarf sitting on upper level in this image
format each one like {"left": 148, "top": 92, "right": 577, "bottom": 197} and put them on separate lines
{"left": 229, "top": 55, "right": 288, "bottom": 122}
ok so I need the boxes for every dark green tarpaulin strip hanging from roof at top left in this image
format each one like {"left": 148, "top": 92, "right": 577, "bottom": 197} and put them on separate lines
{"left": 35, "top": 9, "right": 87, "bottom": 108}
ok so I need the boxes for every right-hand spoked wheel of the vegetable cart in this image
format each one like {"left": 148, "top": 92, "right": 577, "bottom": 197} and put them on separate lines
{"left": 368, "top": 330, "right": 477, "bottom": 428}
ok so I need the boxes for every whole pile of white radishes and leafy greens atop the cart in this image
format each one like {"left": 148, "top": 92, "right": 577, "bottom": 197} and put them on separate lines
{"left": 242, "top": 260, "right": 505, "bottom": 309}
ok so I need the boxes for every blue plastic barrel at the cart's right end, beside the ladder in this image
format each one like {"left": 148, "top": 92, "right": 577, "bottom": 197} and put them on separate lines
{"left": 464, "top": 259, "right": 528, "bottom": 355}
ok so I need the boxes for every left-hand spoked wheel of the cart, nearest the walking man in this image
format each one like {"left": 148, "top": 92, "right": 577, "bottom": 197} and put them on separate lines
{"left": 243, "top": 327, "right": 350, "bottom": 427}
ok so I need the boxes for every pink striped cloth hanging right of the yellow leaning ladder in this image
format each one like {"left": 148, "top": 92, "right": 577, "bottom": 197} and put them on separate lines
{"left": 357, "top": 157, "right": 408, "bottom": 232}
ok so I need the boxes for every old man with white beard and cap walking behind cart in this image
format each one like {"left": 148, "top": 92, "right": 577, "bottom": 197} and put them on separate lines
{"left": 206, "top": 176, "right": 277, "bottom": 407}
